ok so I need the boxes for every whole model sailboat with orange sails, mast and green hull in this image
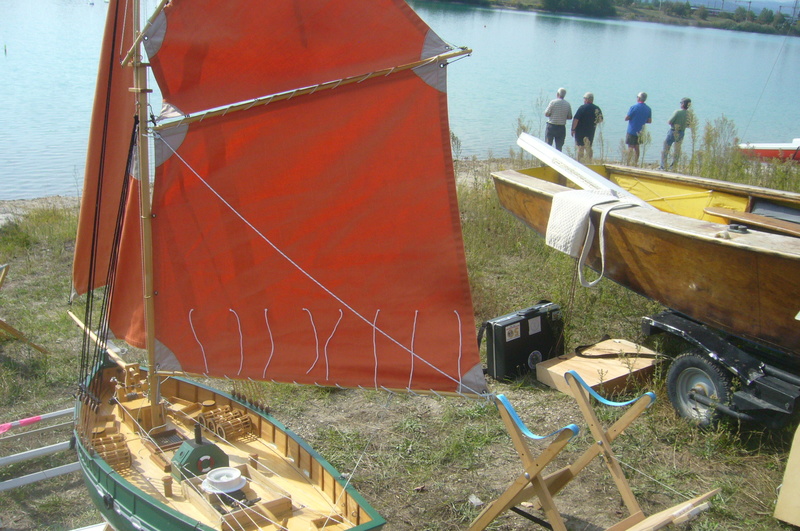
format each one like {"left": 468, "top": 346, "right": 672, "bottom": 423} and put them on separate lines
{"left": 73, "top": 0, "right": 485, "bottom": 529}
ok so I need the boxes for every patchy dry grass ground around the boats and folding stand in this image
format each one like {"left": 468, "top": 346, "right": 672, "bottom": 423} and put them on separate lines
{"left": 0, "top": 140, "right": 800, "bottom": 530}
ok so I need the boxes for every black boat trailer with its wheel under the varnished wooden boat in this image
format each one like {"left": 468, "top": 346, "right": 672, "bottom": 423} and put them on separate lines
{"left": 642, "top": 310, "right": 800, "bottom": 428}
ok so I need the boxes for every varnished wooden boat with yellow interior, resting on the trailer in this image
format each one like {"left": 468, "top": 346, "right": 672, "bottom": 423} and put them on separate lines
{"left": 493, "top": 165, "right": 800, "bottom": 364}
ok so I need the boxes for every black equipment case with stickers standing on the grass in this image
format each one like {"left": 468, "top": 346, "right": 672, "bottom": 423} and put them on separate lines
{"left": 484, "top": 301, "right": 564, "bottom": 380}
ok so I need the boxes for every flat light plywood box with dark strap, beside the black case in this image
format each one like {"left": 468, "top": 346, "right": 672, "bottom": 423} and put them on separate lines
{"left": 536, "top": 339, "right": 658, "bottom": 394}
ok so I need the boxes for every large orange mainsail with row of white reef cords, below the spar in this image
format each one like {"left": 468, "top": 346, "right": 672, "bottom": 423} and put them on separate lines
{"left": 153, "top": 65, "right": 485, "bottom": 392}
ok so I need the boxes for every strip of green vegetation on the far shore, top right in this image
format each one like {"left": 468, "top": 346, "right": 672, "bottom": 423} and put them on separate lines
{"left": 434, "top": 0, "right": 800, "bottom": 37}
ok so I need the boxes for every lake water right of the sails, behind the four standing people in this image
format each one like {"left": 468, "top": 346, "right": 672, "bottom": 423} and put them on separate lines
{"left": 412, "top": 1, "right": 800, "bottom": 161}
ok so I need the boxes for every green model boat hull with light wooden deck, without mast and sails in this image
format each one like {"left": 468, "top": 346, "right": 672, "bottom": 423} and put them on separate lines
{"left": 76, "top": 365, "right": 385, "bottom": 531}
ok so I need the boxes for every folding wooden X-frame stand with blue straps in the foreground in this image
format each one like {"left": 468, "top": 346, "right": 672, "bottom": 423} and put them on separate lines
{"left": 470, "top": 371, "right": 719, "bottom": 531}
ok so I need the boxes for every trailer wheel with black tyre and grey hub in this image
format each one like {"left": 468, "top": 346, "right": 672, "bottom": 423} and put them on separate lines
{"left": 667, "top": 352, "right": 732, "bottom": 426}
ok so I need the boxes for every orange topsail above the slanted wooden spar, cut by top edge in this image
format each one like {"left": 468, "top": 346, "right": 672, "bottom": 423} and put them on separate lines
{"left": 145, "top": 0, "right": 444, "bottom": 114}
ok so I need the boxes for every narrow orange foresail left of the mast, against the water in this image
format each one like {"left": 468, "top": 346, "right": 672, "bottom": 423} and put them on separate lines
{"left": 72, "top": 0, "right": 135, "bottom": 294}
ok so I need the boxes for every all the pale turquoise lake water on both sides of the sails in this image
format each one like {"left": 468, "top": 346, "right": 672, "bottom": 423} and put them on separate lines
{"left": 0, "top": 0, "right": 800, "bottom": 199}
